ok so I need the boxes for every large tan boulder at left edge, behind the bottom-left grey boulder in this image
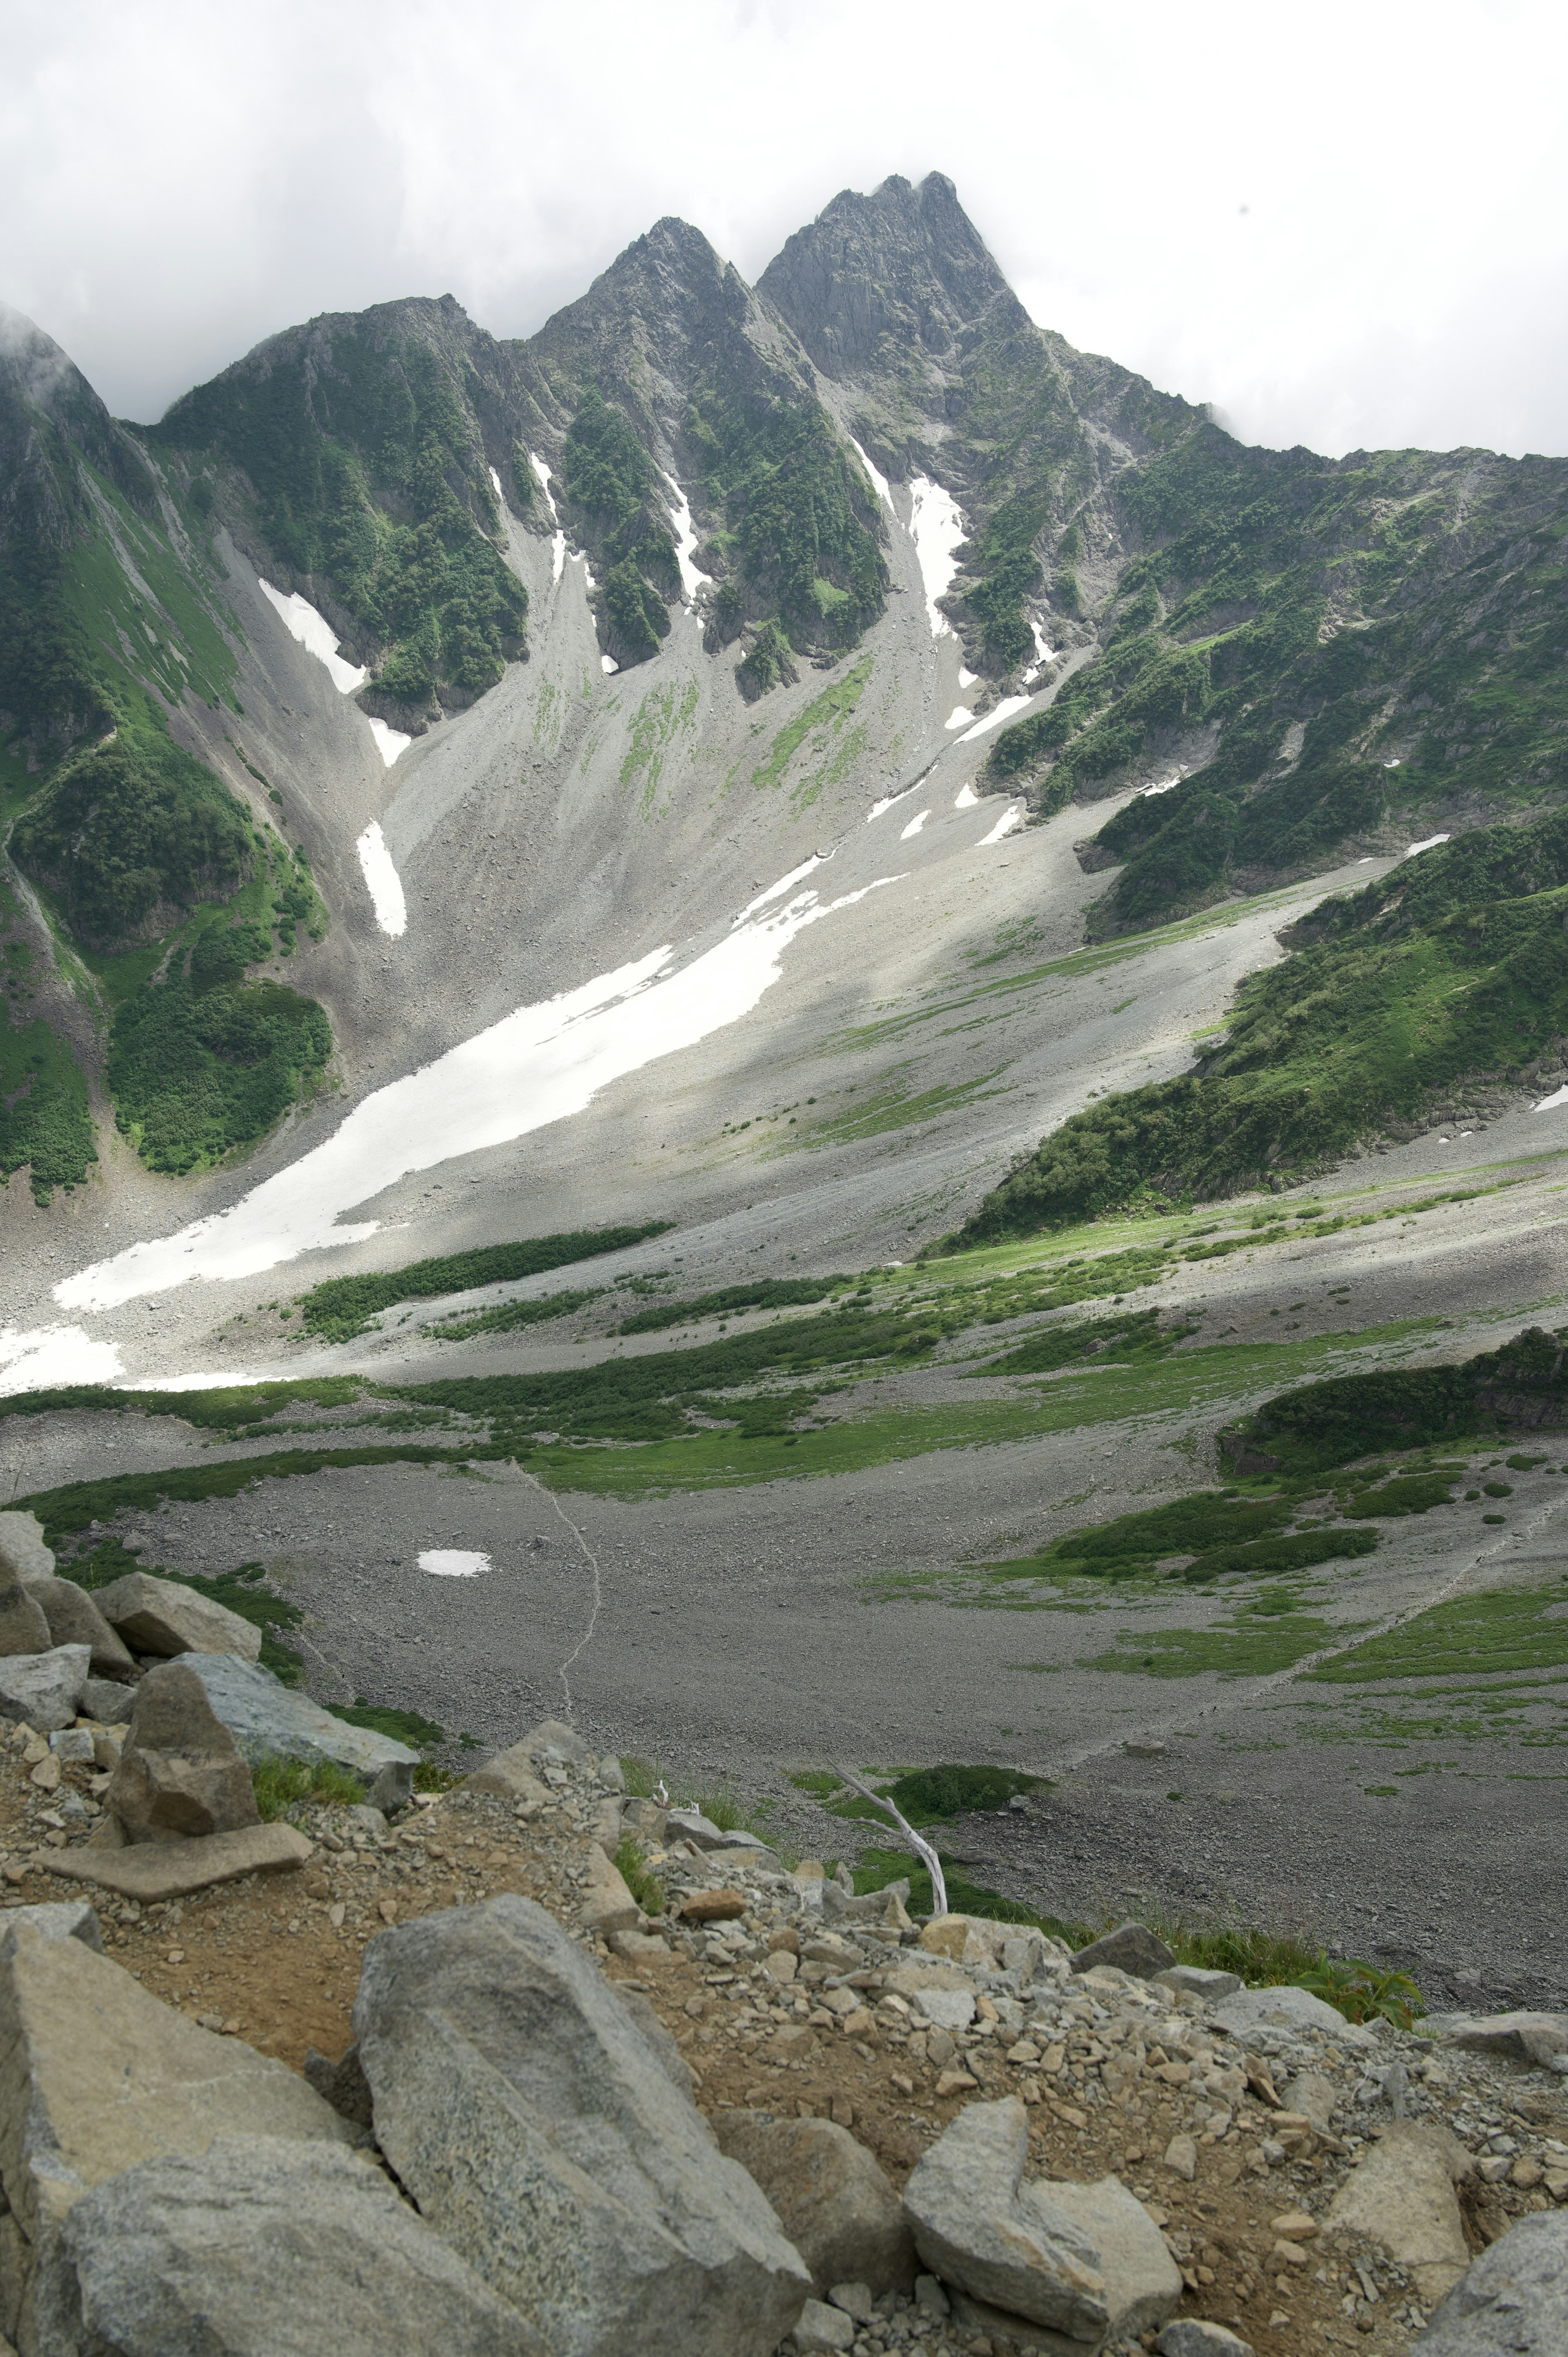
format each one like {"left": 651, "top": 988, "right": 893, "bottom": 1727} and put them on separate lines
{"left": 0, "top": 1926, "right": 354, "bottom": 2352}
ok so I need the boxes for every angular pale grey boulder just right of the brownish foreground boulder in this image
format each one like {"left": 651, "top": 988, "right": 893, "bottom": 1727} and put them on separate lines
{"left": 903, "top": 2095, "right": 1111, "bottom": 2350}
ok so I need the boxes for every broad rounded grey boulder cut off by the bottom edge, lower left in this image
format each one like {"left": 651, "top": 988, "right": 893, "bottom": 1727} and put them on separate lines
{"left": 64, "top": 2136, "right": 537, "bottom": 2357}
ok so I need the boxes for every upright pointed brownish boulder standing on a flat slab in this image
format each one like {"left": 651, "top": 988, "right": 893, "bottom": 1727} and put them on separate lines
{"left": 104, "top": 1662, "right": 262, "bottom": 1843}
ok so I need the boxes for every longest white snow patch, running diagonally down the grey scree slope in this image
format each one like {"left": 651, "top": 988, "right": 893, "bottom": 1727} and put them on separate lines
{"left": 61, "top": 877, "right": 901, "bottom": 1310}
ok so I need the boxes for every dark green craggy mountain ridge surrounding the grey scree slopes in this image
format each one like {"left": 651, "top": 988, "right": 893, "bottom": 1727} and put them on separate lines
{"left": 0, "top": 174, "right": 1568, "bottom": 1235}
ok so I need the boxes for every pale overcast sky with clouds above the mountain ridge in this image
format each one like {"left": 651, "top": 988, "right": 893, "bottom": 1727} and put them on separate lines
{"left": 0, "top": 0, "right": 1568, "bottom": 455}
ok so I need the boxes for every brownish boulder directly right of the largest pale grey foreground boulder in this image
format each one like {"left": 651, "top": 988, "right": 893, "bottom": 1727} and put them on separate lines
{"left": 712, "top": 2112, "right": 915, "bottom": 2293}
